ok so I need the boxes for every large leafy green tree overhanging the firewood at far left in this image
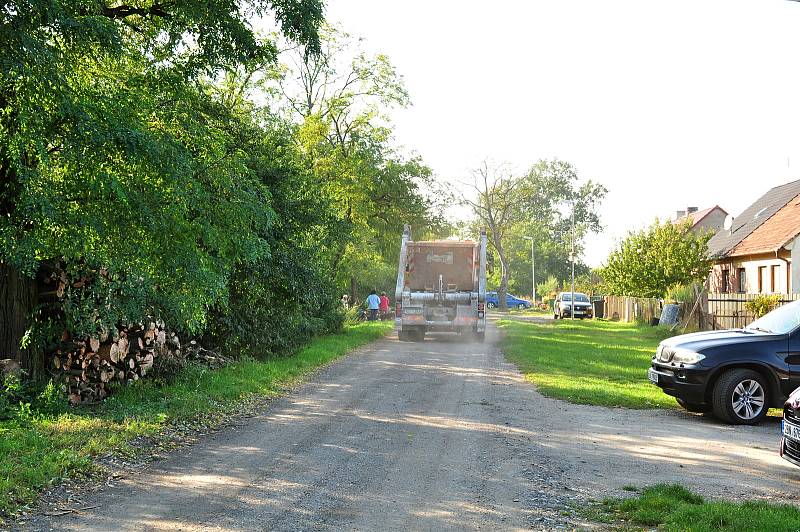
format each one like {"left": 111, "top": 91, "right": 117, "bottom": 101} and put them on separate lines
{"left": 0, "top": 0, "right": 322, "bottom": 372}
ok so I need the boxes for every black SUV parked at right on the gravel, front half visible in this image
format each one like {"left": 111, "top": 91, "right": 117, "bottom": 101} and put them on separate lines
{"left": 647, "top": 301, "right": 800, "bottom": 425}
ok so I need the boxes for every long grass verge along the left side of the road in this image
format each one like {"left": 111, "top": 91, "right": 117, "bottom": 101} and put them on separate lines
{"left": 0, "top": 322, "right": 393, "bottom": 524}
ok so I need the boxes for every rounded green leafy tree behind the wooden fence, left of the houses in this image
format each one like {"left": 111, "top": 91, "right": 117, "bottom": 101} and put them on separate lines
{"left": 601, "top": 220, "right": 711, "bottom": 297}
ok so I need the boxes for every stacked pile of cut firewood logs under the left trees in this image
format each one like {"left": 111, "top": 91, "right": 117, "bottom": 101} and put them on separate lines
{"left": 53, "top": 322, "right": 183, "bottom": 404}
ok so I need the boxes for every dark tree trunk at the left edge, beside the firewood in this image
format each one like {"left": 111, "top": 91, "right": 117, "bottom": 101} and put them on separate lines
{"left": 0, "top": 262, "right": 43, "bottom": 378}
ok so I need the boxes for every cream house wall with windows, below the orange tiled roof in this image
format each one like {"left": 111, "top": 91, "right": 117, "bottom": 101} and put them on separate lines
{"left": 709, "top": 250, "right": 800, "bottom": 294}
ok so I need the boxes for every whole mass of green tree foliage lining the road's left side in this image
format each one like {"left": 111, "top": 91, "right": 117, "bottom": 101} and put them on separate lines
{"left": 0, "top": 4, "right": 444, "bottom": 372}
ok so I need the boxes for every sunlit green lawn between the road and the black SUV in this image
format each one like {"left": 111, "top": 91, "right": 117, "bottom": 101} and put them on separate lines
{"left": 498, "top": 319, "right": 677, "bottom": 408}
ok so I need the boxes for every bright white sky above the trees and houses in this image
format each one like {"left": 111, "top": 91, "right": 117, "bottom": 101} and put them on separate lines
{"left": 327, "top": 0, "right": 800, "bottom": 266}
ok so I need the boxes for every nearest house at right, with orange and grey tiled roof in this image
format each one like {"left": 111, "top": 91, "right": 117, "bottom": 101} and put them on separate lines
{"left": 708, "top": 180, "right": 800, "bottom": 294}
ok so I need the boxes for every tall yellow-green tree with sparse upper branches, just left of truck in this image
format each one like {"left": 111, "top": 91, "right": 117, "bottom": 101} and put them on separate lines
{"left": 279, "top": 27, "right": 447, "bottom": 298}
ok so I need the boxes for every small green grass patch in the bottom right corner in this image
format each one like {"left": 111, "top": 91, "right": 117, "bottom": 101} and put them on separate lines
{"left": 586, "top": 484, "right": 800, "bottom": 532}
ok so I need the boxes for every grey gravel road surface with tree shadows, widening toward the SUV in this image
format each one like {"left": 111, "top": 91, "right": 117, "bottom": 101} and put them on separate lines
{"left": 21, "top": 322, "right": 800, "bottom": 530}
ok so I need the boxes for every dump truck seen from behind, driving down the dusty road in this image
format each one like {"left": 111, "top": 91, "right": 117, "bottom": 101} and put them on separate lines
{"left": 395, "top": 225, "right": 487, "bottom": 341}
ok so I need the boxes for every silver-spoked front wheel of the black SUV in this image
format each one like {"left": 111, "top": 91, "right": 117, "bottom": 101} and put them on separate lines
{"left": 712, "top": 369, "right": 769, "bottom": 425}
